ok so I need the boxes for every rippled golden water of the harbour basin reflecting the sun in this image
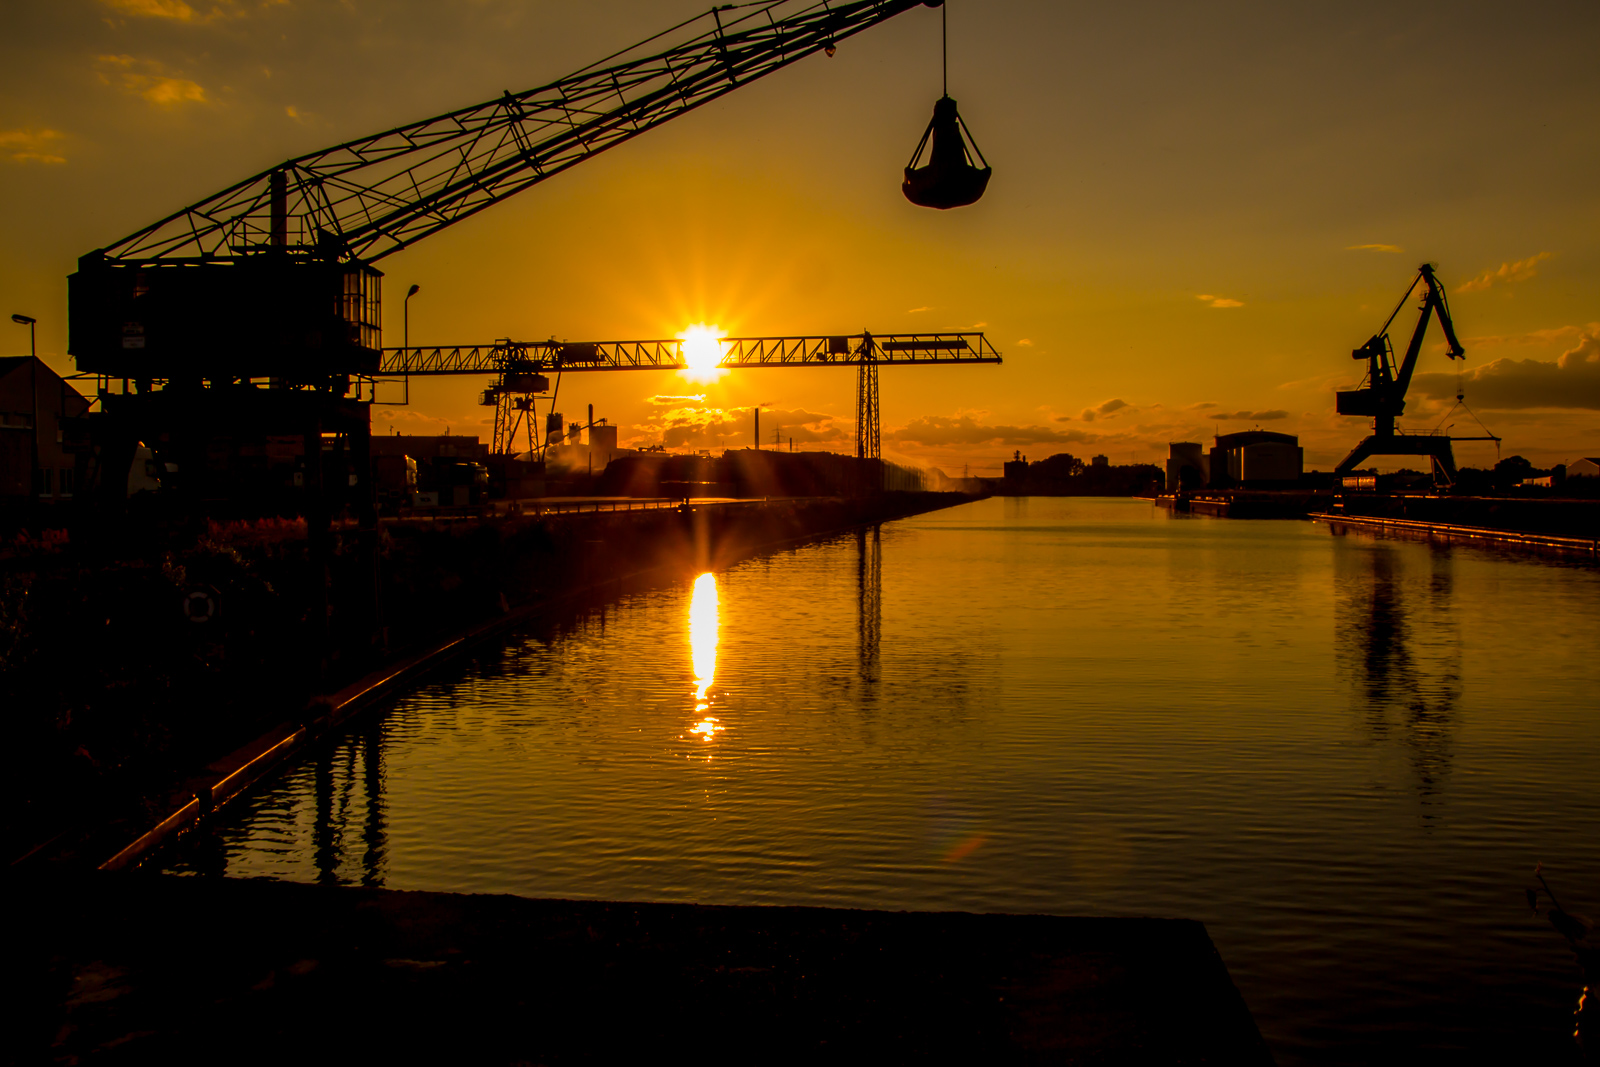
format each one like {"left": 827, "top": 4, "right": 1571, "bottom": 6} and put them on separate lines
{"left": 171, "top": 499, "right": 1600, "bottom": 1062}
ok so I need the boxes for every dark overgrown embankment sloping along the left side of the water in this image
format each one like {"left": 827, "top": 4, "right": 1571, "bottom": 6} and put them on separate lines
{"left": 0, "top": 493, "right": 970, "bottom": 859}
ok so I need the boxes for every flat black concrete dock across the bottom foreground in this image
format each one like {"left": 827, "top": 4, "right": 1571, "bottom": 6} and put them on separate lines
{"left": 8, "top": 873, "right": 1272, "bottom": 1064}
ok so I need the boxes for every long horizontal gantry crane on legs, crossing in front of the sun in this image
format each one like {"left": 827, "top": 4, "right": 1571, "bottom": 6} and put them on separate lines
{"left": 379, "top": 331, "right": 1000, "bottom": 459}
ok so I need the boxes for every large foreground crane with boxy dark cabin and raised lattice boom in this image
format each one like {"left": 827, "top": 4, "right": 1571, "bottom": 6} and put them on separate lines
{"left": 59, "top": 0, "right": 972, "bottom": 496}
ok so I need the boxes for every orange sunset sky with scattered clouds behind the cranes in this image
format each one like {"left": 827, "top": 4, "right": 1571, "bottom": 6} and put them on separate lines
{"left": 0, "top": 0, "right": 1600, "bottom": 474}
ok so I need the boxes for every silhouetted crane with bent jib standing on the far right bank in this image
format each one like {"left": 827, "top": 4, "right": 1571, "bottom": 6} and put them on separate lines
{"left": 1334, "top": 262, "right": 1478, "bottom": 482}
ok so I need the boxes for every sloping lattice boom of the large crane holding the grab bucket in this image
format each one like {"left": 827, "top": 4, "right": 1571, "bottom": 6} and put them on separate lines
{"left": 104, "top": 0, "right": 923, "bottom": 262}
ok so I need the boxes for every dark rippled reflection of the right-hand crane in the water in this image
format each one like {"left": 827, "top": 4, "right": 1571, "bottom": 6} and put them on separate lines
{"left": 1338, "top": 544, "right": 1461, "bottom": 797}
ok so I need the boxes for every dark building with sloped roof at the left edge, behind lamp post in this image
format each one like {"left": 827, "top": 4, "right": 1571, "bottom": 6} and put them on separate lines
{"left": 0, "top": 355, "right": 90, "bottom": 504}
